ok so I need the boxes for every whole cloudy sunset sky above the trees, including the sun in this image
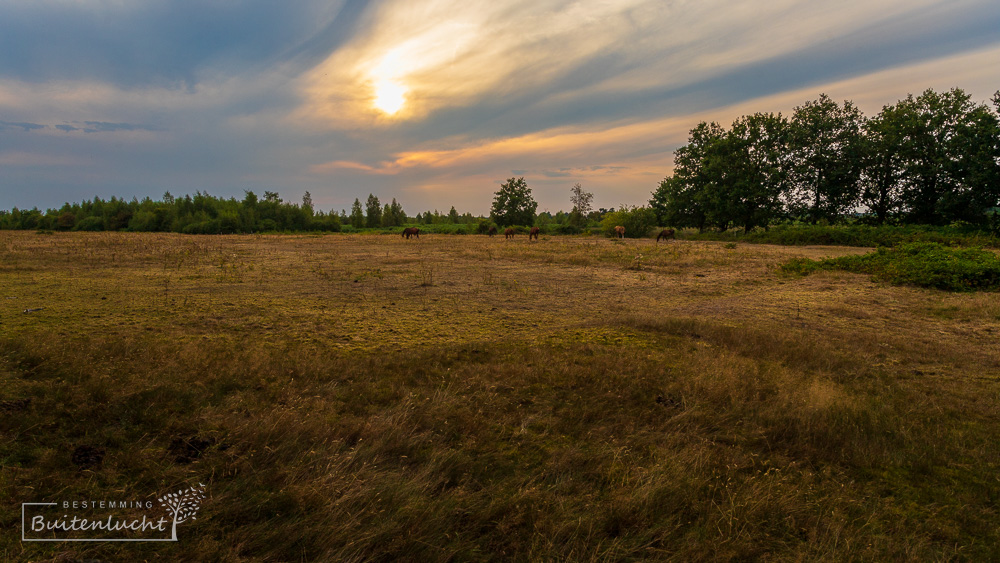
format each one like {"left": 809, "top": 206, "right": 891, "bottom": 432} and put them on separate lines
{"left": 0, "top": 0, "right": 1000, "bottom": 215}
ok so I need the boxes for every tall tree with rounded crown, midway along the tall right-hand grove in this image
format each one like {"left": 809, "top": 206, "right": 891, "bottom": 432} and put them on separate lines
{"left": 789, "top": 94, "right": 864, "bottom": 224}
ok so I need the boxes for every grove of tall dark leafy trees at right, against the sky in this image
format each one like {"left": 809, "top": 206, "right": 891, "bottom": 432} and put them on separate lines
{"left": 650, "top": 89, "right": 1000, "bottom": 232}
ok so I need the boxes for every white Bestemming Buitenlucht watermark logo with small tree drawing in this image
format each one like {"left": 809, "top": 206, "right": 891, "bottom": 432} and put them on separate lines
{"left": 21, "top": 483, "right": 205, "bottom": 542}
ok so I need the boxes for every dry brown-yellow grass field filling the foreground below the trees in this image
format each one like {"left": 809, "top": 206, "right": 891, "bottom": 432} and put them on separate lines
{"left": 0, "top": 231, "right": 1000, "bottom": 562}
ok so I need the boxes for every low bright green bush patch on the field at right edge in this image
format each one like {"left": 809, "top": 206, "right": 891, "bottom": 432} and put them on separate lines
{"left": 781, "top": 242, "right": 1000, "bottom": 291}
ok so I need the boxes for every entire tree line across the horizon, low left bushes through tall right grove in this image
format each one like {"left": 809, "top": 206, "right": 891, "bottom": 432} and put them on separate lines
{"left": 0, "top": 88, "right": 1000, "bottom": 236}
